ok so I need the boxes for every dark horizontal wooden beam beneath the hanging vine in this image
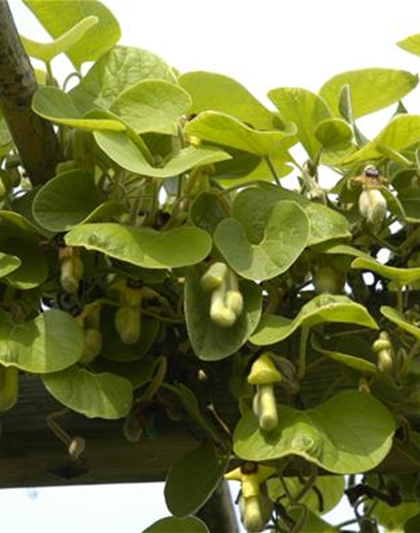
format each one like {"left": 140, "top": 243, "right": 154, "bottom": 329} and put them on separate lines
{"left": 0, "top": 376, "right": 419, "bottom": 488}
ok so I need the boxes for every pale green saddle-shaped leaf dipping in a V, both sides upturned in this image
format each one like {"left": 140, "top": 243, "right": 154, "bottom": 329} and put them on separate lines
{"left": 94, "top": 131, "right": 230, "bottom": 178}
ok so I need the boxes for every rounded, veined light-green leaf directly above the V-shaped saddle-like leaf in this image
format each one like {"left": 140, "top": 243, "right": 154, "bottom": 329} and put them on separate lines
{"left": 110, "top": 80, "right": 191, "bottom": 135}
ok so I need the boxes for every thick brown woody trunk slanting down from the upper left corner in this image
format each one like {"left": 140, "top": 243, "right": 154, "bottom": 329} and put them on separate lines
{"left": 0, "top": 0, "right": 60, "bottom": 185}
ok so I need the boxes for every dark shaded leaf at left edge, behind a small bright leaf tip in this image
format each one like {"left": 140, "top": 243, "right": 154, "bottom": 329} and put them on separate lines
{"left": 0, "top": 237, "right": 48, "bottom": 290}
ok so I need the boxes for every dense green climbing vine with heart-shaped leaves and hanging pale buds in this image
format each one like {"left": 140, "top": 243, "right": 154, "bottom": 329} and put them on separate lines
{"left": 0, "top": 0, "right": 420, "bottom": 533}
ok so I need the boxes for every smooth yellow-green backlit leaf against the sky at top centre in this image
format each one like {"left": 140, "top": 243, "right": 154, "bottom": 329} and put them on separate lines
{"left": 178, "top": 71, "right": 275, "bottom": 130}
